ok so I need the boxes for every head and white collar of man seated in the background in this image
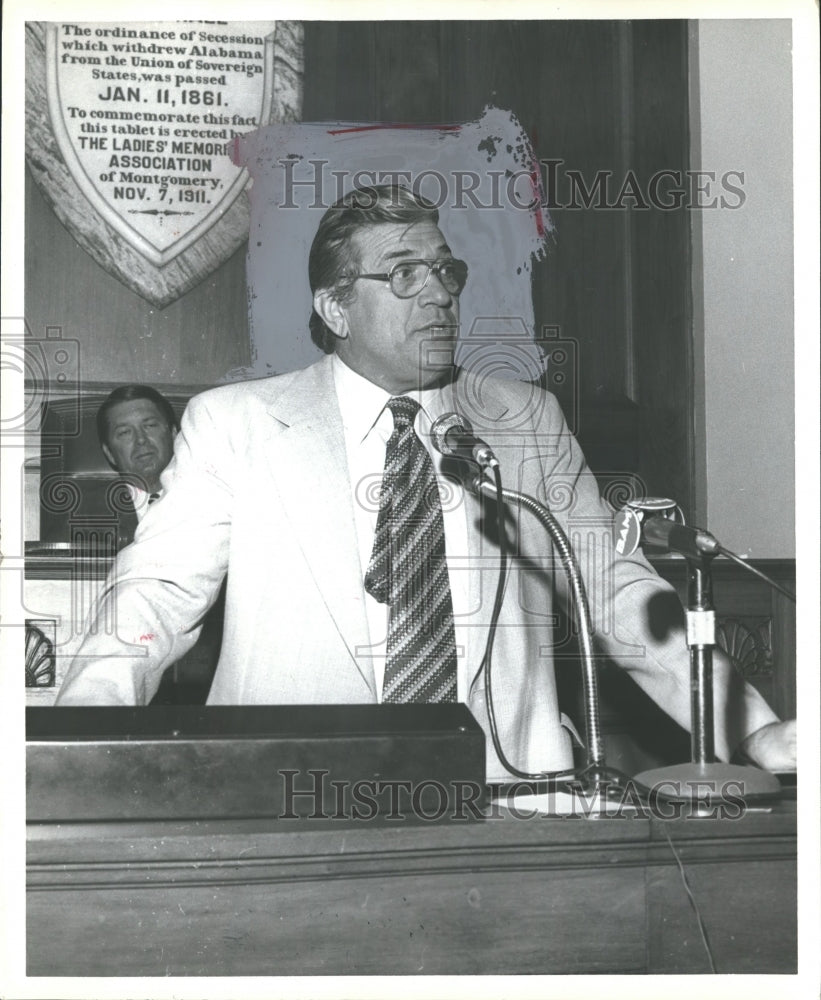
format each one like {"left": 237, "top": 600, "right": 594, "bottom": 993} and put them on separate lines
{"left": 97, "top": 385, "right": 180, "bottom": 521}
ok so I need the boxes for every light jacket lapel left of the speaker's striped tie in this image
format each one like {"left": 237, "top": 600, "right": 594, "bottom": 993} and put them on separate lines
{"left": 266, "top": 358, "right": 376, "bottom": 698}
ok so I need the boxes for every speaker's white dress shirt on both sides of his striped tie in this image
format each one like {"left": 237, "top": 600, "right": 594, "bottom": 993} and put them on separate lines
{"left": 333, "top": 355, "right": 470, "bottom": 701}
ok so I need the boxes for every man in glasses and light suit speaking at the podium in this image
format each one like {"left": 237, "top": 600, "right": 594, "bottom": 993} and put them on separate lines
{"left": 58, "top": 187, "right": 794, "bottom": 780}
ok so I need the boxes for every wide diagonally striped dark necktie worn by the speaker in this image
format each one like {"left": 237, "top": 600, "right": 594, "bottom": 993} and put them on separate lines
{"left": 365, "top": 396, "right": 456, "bottom": 702}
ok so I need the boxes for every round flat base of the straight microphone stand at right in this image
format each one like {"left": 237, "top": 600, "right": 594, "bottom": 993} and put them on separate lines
{"left": 634, "top": 762, "right": 783, "bottom": 804}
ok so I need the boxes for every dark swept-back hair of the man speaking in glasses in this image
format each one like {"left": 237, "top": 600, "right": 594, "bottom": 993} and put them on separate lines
{"left": 308, "top": 184, "right": 439, "bottom": 354}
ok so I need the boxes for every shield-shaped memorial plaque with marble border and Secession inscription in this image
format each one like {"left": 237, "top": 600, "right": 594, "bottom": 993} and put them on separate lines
{"left": 26, "top": 21, "right": 302, "bottom": 306}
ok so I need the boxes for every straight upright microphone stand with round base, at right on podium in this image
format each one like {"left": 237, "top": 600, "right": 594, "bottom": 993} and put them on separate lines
{"left": 635, "top": 551, "right": 781, "bottom": 806}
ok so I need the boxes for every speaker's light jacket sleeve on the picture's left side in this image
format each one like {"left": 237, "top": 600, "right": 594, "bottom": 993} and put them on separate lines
{"left": 56, "top": 394, "right": 234, "bottom": 705}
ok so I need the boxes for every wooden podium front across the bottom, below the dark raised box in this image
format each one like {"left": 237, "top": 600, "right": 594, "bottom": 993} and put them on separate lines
{"left": 27, "top": 709, "right": 797, "bottom": 976}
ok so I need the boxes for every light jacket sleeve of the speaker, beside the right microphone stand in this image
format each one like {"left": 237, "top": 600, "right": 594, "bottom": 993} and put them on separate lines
{"left": 525, "top": 395, "right": 777, "bottom": 760}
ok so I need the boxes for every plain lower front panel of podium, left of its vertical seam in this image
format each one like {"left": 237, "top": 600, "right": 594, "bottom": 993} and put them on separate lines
{"left": 28, "top": 868, "right": 645, "bottom": 976}
